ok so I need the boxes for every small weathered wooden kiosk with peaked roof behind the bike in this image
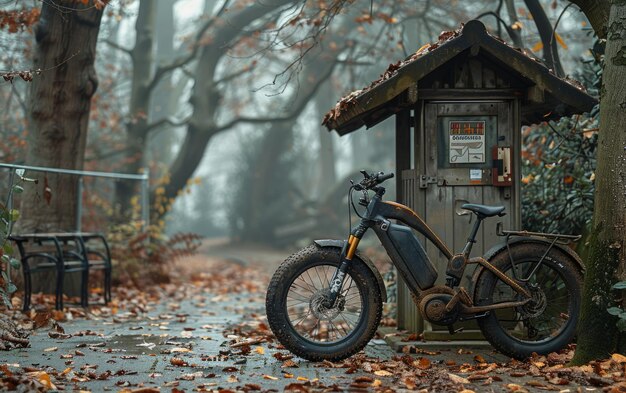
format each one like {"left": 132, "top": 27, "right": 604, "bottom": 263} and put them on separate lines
{"left": 324, "top": 20, "right": 597, "bottom": 339}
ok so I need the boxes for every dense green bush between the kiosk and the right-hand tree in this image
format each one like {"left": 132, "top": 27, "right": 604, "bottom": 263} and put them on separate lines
{"left": 521, "top": 109, "right": 598, "bottom": 234}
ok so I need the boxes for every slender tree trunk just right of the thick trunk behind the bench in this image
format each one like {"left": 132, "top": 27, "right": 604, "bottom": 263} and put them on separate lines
{"left": 115, "top": 0, "right": 158, "bottom": 214}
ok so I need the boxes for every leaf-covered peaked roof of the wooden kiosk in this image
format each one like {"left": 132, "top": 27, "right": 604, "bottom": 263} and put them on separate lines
{"left": 322, "top": 20, "right": 597, "bottom": 135}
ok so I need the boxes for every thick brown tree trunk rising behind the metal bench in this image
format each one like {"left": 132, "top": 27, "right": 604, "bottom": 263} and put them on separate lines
{"left": 19, "top": 2, "right": 102, "bottom": 231}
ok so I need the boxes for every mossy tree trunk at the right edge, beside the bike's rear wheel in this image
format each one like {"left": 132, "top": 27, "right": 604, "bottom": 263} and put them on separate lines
{"left": 572, "top": 1, "right": 626, "bottom": 364}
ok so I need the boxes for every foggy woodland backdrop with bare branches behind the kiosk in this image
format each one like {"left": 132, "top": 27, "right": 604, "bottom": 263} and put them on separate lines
{"left": 0, "top": 0, "right": 599, "bottom": 247}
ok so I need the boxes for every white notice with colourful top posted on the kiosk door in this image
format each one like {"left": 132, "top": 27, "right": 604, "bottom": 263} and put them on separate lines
{"left": 448, "top": 120, "right": 485, "bottom": 164}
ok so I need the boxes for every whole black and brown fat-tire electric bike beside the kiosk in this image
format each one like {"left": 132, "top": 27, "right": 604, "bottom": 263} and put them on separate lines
{"left": 266, "top": 171, "right": 584, "bottom": 361}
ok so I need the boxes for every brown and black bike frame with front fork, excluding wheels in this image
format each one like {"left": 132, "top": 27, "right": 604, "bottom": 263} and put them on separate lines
{"left": 328, "top": 187, "right": 531, "bottom": 314}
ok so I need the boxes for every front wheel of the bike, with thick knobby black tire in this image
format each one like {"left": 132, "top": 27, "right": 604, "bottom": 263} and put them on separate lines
{"left": 266, "top": 245, "right": 382, "bottom": 361}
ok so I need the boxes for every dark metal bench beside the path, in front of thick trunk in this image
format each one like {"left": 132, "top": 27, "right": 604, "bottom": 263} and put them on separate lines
{"left": 10, "top": 232, "right": 112, "bottom": 311}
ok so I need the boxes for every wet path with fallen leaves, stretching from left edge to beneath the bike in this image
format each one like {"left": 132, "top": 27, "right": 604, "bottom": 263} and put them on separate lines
{"left": 0, "top": 243, "right": 601, "bottom": 393}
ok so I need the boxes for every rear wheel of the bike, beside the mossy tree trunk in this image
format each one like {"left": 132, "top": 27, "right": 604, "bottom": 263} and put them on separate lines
{"left": 474, "top": 243, "right": 583, "bottom": 359}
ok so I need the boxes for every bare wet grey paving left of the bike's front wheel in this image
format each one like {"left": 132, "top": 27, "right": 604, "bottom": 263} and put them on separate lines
{"left": 2, "top": 288, "right": 400, "bottom": 392}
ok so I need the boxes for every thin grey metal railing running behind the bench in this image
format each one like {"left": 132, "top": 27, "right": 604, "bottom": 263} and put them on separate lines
{"left": 0, "top": 163, "right": 150, "bottom": 232}
